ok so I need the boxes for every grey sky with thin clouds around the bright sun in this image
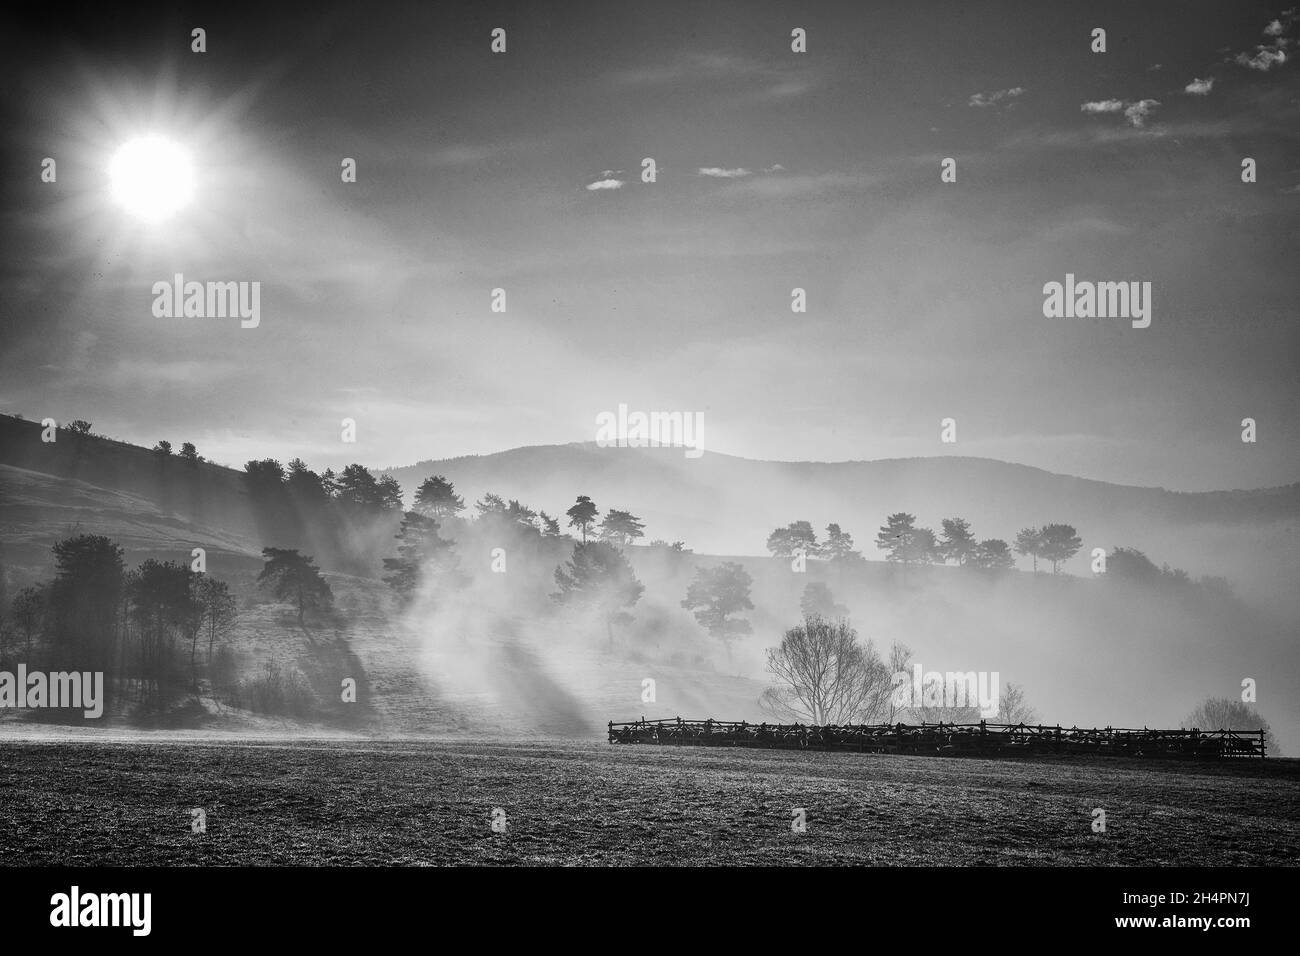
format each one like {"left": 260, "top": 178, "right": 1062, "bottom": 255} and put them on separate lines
{"left": 0, "top": 0, "right": 1300, "bottom": 490}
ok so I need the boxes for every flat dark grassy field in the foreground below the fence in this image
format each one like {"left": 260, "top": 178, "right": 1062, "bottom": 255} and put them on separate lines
{"left": 0, "top": 737, "right": 1300, "bottom": 866}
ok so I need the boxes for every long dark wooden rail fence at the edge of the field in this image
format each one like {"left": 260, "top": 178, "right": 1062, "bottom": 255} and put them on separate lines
{"left": 610, "top": 717, "right": 1265, "bottom": 760}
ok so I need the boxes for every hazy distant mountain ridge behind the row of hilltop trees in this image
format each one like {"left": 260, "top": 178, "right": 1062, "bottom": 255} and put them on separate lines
{"left": 385, "top": 442, "right": 1300, "bottom": 574}
